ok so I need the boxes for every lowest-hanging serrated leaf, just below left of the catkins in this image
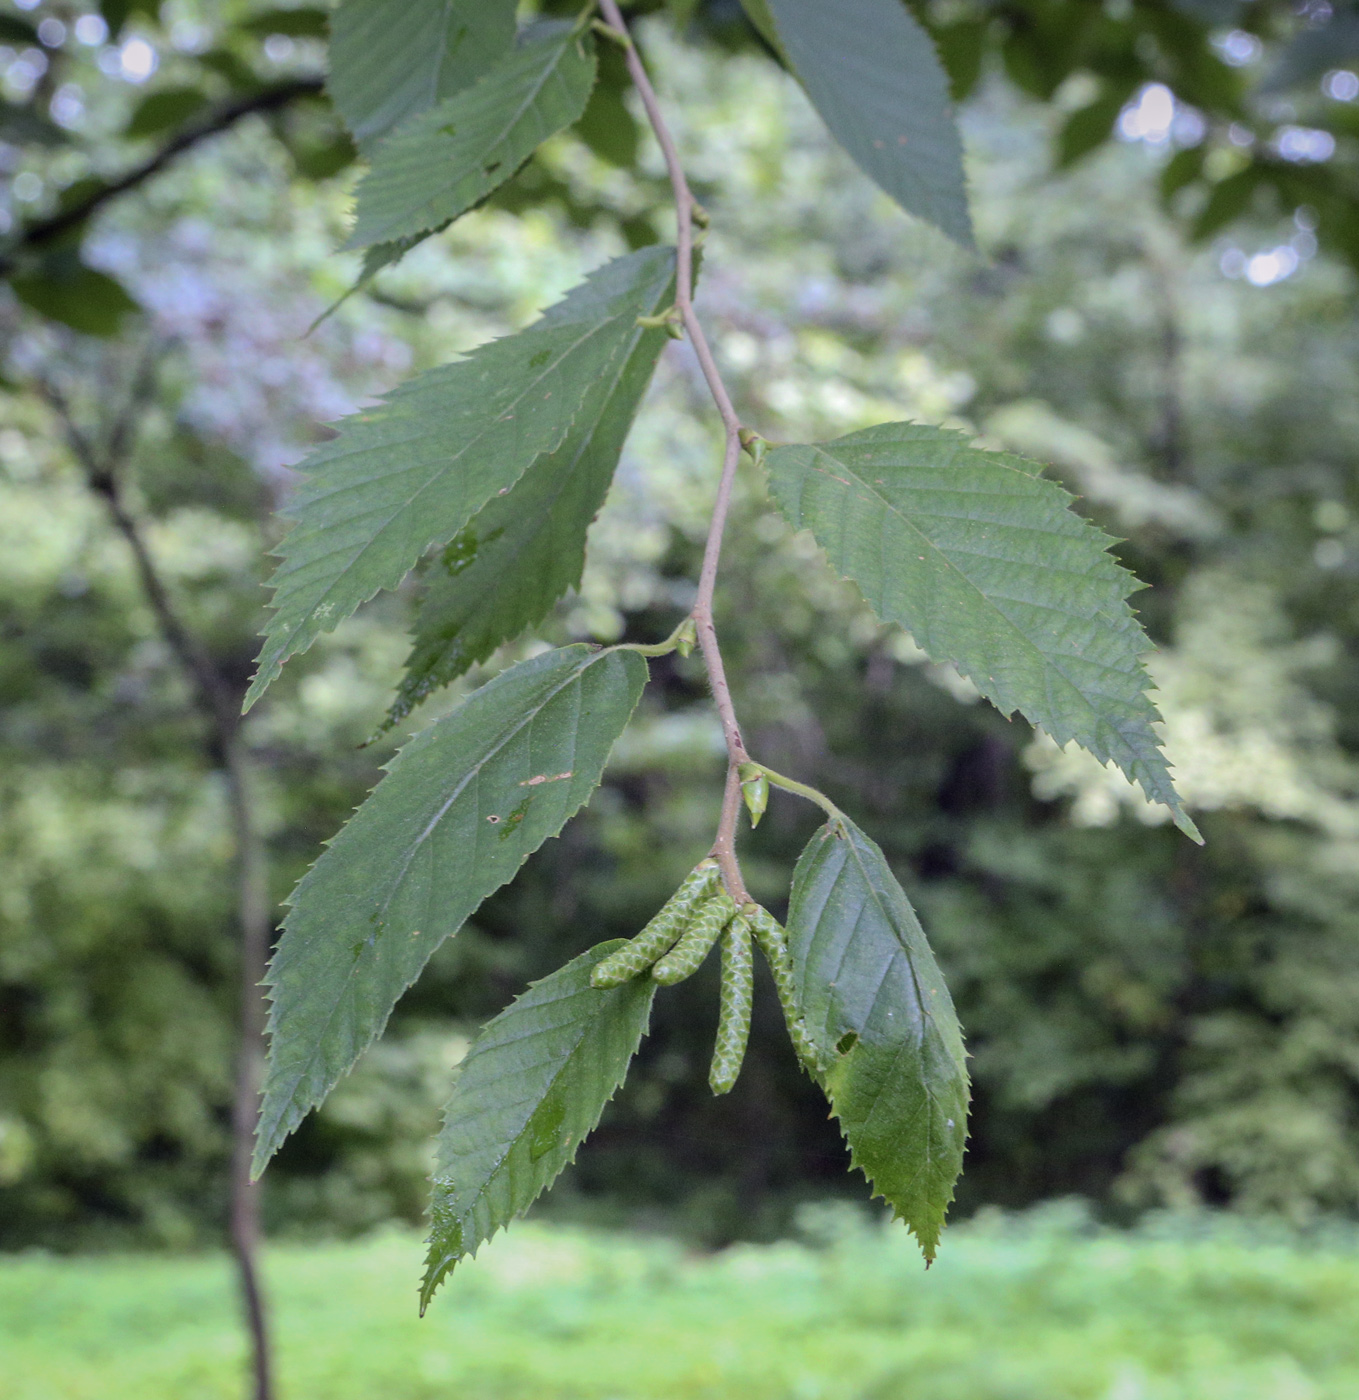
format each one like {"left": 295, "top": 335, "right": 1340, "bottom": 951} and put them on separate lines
{"left": 420, "top": 938, "right": 656, "bottom": 1312}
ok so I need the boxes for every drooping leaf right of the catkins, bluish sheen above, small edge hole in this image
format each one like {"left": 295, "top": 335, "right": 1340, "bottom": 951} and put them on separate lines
{"left": 788, "top": 818, "right": 967, "bottom": 1261}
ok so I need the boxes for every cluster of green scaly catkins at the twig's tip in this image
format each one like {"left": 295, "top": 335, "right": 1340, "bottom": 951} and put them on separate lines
{"left": 591, "top": 860, "right": 819, "bottom": 1093}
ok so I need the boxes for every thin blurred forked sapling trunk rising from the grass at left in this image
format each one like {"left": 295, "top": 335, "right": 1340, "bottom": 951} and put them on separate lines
{"left": 34, "top": 364, "right": 273, "bottom": 1400}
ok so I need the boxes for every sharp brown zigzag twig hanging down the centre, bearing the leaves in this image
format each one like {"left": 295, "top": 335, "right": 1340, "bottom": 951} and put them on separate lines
{"left": 599, "top": 0, "right": 750, "bottom": 904}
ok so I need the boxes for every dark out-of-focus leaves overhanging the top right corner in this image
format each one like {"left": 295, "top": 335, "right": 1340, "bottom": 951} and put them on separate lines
{"left": 921, "top": 0, "right": 1359, "bottom": 266}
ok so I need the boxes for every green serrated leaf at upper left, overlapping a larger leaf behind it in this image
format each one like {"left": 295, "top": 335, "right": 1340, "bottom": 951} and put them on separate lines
{"left": 346, "top": 27, "right": 595, "bottom": 248}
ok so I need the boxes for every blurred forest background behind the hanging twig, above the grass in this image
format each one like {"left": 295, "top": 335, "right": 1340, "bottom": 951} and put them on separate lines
{"left": 0, "top": 0, "right": 1359, "bottom": 1249}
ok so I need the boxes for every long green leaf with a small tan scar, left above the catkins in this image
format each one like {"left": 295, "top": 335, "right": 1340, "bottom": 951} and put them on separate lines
{"left": 255, "top": 645, "right": 647, "bottom": 1170}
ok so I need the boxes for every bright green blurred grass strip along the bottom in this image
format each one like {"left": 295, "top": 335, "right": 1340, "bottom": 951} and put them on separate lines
{"left": 0, "top": 1218, "right": 1359, "bottom": 1400}
